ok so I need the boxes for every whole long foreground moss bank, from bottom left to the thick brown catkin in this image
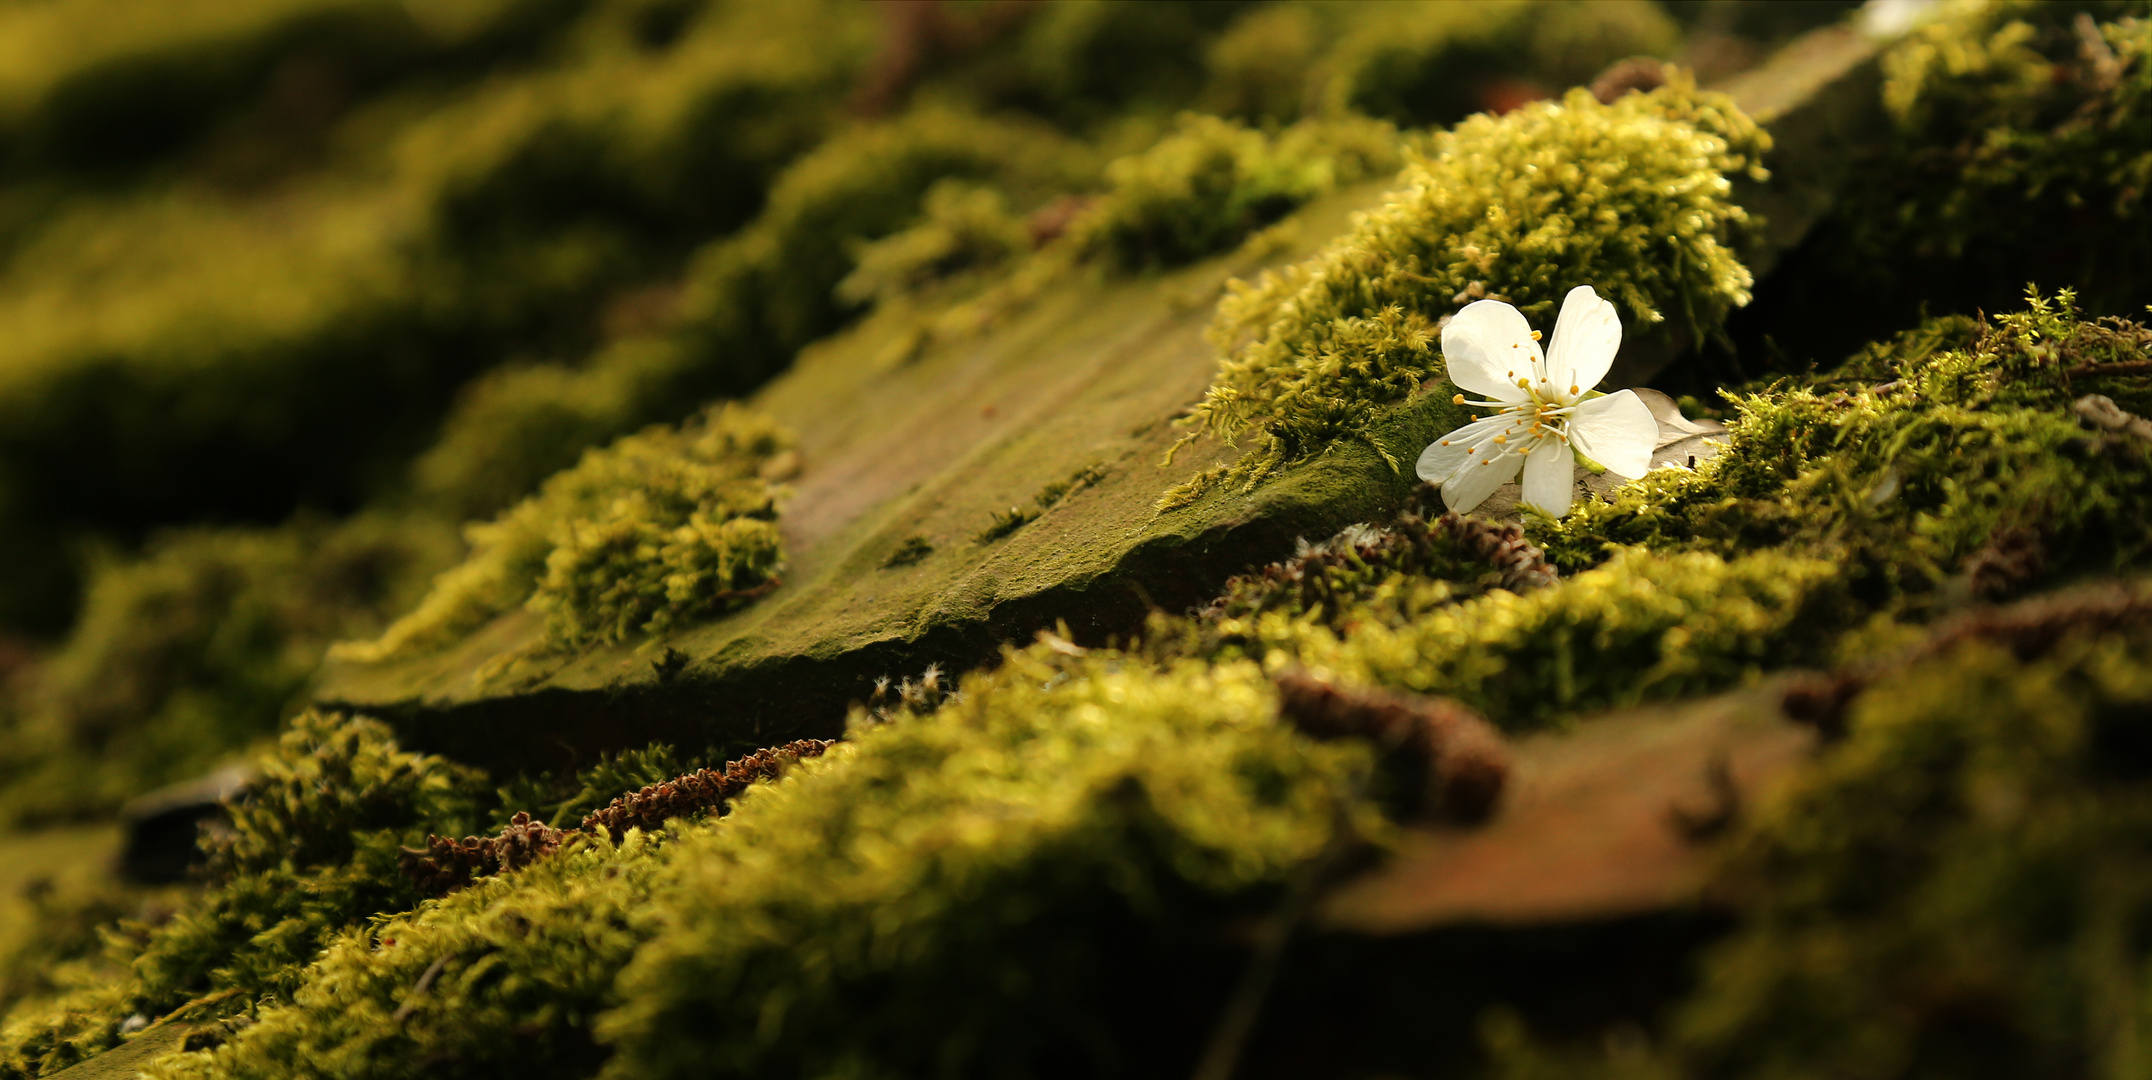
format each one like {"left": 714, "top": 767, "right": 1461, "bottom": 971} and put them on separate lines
{"left": 109, "top": 648, "right": 1379, "bottom": 1080}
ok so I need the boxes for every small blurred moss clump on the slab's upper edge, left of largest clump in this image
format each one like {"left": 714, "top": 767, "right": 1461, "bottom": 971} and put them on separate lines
{"left": 1070, "top": 114, "right": 1407, "bottom": 271}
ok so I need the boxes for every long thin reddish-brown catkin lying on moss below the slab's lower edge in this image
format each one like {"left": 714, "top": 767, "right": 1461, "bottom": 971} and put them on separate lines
{"left": 398, "top": 738, "right": 835, "bottom": 894}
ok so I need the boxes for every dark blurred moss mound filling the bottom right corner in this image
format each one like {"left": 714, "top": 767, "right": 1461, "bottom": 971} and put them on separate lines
{"left": 1493, "top": 579, "right": 2152, "bottom": 1080}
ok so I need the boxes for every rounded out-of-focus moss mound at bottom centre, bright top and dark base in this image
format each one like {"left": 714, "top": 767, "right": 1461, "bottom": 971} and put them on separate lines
{"left": 605, "top": 650, "right": 1364, "bottom": 1078}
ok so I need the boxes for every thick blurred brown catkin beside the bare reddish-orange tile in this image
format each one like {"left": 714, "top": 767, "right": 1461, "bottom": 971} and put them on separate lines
{"left": 1276, "top": 671, "right": 1509, "bottom": 822}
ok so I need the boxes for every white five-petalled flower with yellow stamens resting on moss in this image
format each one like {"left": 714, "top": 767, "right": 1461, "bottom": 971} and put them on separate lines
{"left": 1418, "top": 284, "right": 1659, "bottom": 516}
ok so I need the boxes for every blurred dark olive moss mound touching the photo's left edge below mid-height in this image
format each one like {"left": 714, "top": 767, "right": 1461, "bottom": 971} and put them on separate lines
{"left": 0, "top": 514, "right": 454, "bottom": 822}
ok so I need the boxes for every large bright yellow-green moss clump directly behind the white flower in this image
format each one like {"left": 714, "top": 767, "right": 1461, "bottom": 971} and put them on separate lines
{"left": 1162, "top": 75, "right": 1769, "bottom": 506}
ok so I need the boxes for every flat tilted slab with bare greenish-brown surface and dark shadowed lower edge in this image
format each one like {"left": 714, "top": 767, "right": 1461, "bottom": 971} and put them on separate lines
{"left": 318, "top": 27, "right": 1872, "bottom": 770}
